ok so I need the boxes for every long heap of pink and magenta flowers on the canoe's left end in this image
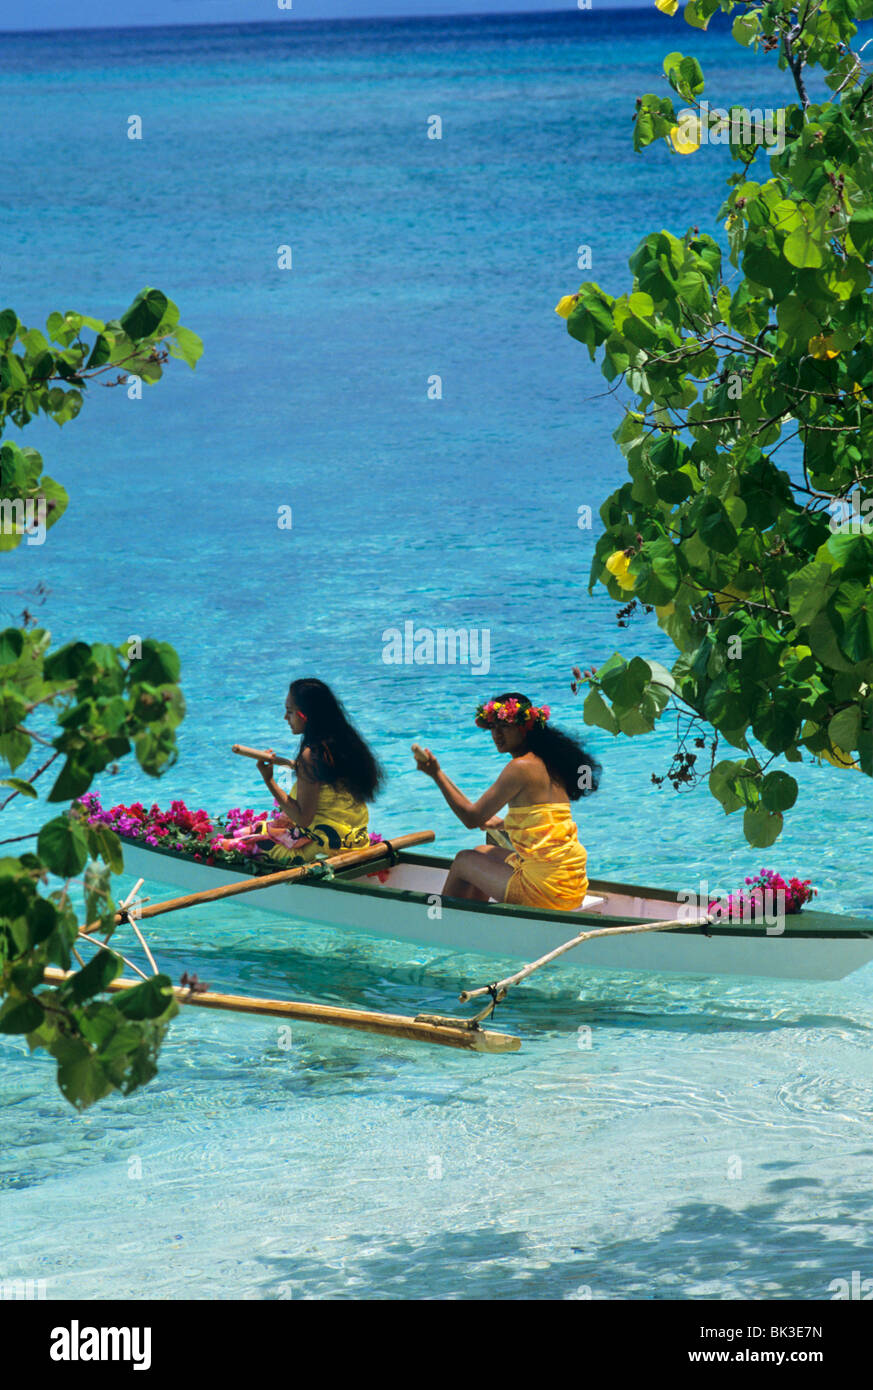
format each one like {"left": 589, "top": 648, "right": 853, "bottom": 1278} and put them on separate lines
{"left": 72, "top": 792, "right": 382, "bottom": 873}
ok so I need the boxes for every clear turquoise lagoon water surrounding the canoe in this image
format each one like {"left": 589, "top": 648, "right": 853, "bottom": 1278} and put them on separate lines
{"left": 0, "top": 10, "right": 873, "bottom": 1298}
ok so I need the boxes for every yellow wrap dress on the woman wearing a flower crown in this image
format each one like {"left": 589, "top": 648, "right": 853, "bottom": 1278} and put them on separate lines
{"left": 503, "top": 802, "right": 588, "bottom": 912}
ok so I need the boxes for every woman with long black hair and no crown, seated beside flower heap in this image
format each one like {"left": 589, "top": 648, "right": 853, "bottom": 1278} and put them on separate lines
{"left": 222, "top": 677, "right": 384, "bottom": 863}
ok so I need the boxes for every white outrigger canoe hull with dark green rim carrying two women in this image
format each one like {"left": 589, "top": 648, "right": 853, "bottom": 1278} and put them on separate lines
{"left": 122, "top": 837, "right": 873, "bottom": 980}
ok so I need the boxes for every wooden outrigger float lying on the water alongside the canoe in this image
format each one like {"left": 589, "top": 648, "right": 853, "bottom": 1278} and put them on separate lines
{"left": 44, "top": 967, "right": 521, "bottom": 1052}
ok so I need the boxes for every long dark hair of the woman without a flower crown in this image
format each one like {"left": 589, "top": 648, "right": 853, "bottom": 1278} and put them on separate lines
{"left": 289, "top": 676, "right": 385, "bottom": 801}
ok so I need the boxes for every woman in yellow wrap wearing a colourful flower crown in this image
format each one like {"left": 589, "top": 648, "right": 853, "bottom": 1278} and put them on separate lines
{"left": 413, "top": 691, "right": 601, "bottom": 912}
